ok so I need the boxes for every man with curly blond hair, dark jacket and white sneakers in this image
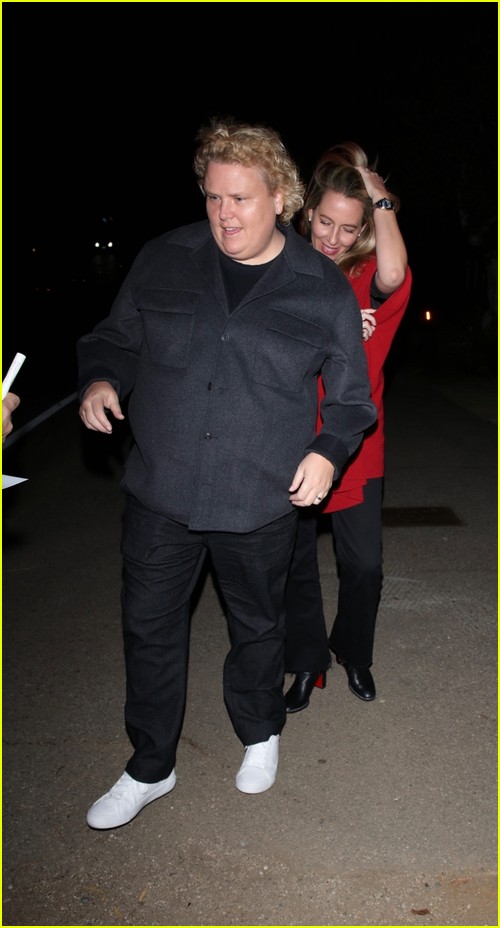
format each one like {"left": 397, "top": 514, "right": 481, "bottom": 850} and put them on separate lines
{"left": 78, "top": 120, "right": 376, "bottom": 828}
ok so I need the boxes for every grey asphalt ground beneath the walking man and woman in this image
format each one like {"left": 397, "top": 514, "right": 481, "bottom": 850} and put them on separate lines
{"left": 2, "top": 370, "right": 498, "bottom": 925}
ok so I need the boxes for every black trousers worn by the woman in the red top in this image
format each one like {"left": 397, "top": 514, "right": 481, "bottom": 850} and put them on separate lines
{"left": 285, "top": 477, "right": 383, "bottom": 673}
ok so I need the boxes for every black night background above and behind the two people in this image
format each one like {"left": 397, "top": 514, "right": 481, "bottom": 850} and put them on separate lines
{"left": 2, "top": 2, "right": 498, "bottom": 426}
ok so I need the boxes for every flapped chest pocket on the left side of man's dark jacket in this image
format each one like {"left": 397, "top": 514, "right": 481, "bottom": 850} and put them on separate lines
{"left": 140, "top": 289, "right": 200, "bottom": 368}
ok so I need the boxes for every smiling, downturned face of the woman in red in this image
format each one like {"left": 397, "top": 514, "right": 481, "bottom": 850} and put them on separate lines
{"left": 308, "top": 190, "right": 364, "bottom": 261}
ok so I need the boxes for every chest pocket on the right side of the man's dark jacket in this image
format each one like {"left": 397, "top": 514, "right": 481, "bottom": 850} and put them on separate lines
{"left": 253, "top": 312, "right": 325, "bottom": 393}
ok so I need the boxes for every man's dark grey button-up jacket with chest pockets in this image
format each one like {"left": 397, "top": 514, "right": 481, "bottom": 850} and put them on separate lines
{"left": 77, "top": 221, "right": 377, "bottom": 532}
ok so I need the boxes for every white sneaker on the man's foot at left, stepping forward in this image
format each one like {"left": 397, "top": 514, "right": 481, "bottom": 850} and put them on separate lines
{"left": 87, "top": 768, "right": 176, "bottom": 828}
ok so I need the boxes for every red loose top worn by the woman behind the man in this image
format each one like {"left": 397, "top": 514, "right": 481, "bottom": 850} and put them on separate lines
{"left": 317, "top": 256, "right": 412, "bottom": 512}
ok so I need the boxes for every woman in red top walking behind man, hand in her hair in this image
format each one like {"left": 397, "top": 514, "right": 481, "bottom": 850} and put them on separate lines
{"left": 285, "top": 142, "right": 411, "bottom": 712}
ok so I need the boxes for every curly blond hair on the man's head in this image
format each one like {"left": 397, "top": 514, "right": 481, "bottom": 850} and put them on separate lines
{"left": 193, "top": 117, "right": 305, "bottom": 225}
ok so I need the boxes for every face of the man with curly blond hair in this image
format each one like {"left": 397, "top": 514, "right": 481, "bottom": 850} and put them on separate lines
{"left": 204, "top": 161, "right": 283, "bottom": 264}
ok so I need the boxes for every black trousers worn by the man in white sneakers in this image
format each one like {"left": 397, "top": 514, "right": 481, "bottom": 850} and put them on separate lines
{"left": 122, "top": 496, "right": 297, "bottom": 783}
